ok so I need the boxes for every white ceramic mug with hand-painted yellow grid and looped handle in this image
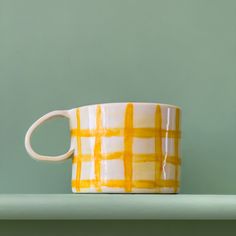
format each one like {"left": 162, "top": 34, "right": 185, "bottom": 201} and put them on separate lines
{"left": 25, "top": 103, "right": 181, "bottom": 193}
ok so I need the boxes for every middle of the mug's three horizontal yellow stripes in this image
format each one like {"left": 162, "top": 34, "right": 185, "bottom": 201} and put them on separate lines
{"left": 72, "top": 152, "right": 181, "bottom": 165}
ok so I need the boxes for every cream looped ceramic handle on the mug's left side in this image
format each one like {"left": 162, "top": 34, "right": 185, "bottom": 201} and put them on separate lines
{"left": 25, "top": 110, "right": 74, "bottom": 161}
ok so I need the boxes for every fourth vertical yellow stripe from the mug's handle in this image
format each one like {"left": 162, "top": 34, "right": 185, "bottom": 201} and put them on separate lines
{"left": 155, "top": 105, "right": 163, "bottom": 192}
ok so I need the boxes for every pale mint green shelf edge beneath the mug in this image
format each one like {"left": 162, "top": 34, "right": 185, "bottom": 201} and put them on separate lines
{"left": 0, "top": 194, "right": 236, "bottom": 220}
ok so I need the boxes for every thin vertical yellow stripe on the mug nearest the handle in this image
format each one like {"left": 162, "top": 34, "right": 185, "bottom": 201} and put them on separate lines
{"left": 74, "top": 109, "right": 82, "bottom": 192}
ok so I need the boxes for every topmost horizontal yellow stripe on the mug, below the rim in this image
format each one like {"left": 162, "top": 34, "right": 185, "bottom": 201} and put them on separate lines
{"left": 71, "top": 128, "right": 181, "bottom": 138}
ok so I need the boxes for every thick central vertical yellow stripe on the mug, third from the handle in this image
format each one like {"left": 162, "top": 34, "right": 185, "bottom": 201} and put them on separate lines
{"left": 124, "top": 103, "right": 133, "bottom": 192}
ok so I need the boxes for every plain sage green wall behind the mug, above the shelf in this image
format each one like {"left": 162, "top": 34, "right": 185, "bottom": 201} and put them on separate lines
{"left": 0, "top": 0, "right": 236, "bottom": 194}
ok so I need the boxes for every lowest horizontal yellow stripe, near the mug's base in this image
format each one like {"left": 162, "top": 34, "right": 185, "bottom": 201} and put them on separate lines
{"left": 72, "top": 180, "right": 179, "bottom": 188}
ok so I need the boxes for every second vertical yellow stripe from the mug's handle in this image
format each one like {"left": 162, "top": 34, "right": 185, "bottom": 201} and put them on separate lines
{"left": 94, "top": 105, "right": 102, "bottom": 192}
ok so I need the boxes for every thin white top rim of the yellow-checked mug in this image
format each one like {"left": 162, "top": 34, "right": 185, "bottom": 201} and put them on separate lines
{"left": 71, "top": 102, "right": 182, "bottom": 111}
